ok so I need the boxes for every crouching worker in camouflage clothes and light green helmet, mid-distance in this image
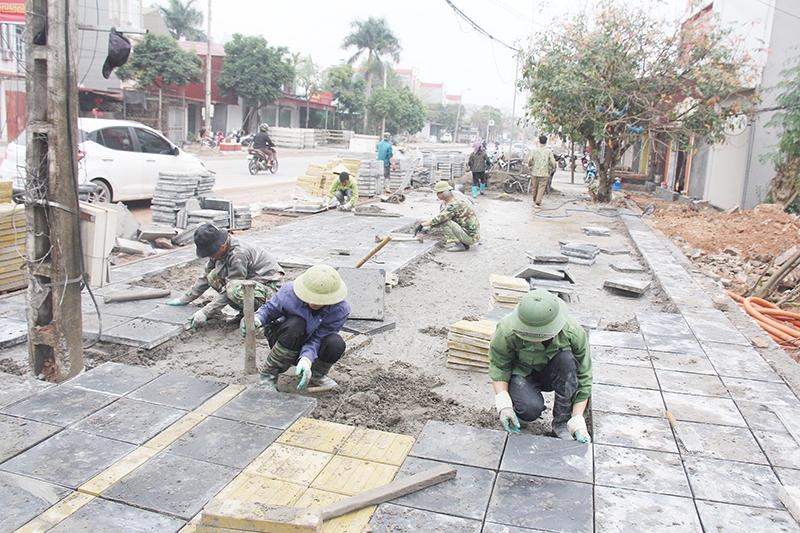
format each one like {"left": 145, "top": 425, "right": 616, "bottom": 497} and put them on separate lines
{"left": 418, "top": 181, "right": 481, "bottom": 252}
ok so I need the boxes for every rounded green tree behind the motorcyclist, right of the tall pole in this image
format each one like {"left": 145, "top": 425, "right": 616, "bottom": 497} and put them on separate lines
{"left": 216, "top": 33, "right": 294, "bottom": 131}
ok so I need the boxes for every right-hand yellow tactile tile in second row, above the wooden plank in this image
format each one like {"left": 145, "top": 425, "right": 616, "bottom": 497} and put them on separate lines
{"left": 310, "top": 455, "right": 399, "bottom": 496}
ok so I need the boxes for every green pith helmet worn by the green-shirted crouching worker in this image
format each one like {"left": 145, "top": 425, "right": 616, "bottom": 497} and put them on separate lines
{"left": 510, "top": 289, "right": 569, "bottom": 341}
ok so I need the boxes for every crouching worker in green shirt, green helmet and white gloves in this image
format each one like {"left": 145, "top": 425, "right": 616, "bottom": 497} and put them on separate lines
{"left": 489, "top": 289, "right": 592, "bottom": 442}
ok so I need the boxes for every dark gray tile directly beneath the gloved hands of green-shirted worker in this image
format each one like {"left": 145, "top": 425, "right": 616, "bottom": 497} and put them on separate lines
{"left": 500, "top": 434, "right": 592, "bottom": 483}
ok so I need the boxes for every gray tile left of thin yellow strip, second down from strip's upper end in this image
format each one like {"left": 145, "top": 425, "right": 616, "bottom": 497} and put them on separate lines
{"left": 73, "top": 398, "right": 186, "bottom": 444}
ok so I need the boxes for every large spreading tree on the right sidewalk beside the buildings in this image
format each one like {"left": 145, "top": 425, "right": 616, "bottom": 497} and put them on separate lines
{"left": 522, "top": 0, "right": 754, "bottom": 202}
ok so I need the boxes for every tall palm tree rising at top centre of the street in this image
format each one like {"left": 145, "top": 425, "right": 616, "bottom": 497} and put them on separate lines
{"left": 342, "top": 17, "right": 401, "bottom": 130}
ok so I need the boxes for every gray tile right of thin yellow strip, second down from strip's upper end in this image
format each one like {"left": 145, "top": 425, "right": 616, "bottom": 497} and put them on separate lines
{"left": 167, "top": 416, "right": 283, "bottom": 470}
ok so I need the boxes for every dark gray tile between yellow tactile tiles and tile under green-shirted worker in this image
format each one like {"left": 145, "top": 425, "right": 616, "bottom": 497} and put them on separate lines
{"left": 409, "top": 420, "right": 506, "bottom": 469}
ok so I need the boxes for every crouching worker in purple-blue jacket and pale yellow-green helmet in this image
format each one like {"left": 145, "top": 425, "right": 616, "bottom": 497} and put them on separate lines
{"left": 242, "top": 265, "right": 350, "bottom": 391}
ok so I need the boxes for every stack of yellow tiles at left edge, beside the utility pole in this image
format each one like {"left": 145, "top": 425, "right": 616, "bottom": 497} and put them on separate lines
{"left": 0, "top": 181, "right": 27, "bottom": 292}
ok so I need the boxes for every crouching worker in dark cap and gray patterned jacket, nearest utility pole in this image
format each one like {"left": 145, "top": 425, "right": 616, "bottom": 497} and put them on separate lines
{"left": 167, "top": 224, "right": 285, "bottom": 328}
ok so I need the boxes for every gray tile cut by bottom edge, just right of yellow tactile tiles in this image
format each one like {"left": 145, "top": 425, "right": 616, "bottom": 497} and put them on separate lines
{"left": 369, "top": 503, "right": 481, "bottom": 533}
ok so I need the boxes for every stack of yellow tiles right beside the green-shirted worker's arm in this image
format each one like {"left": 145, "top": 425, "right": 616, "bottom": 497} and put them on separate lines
{"left": 446, "top": 320, "right": 497, "bottom": 372}
